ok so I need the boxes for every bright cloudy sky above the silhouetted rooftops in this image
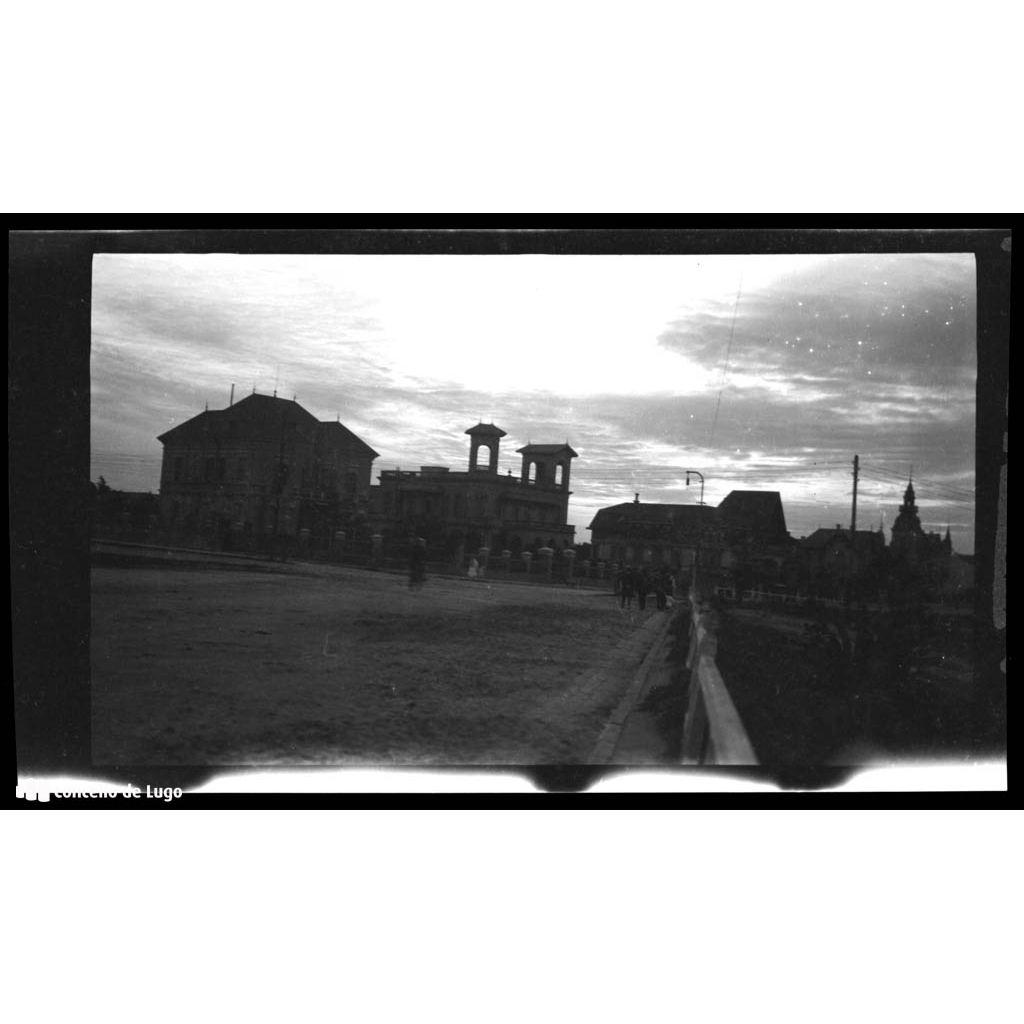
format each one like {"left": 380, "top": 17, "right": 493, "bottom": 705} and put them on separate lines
{"left": 91, "top": 253, "right": 977, "bottom": 553}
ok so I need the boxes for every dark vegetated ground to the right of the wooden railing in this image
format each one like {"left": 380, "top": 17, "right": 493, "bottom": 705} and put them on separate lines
{"left": 717, "top": 611, "right": 984, "bottom": 765}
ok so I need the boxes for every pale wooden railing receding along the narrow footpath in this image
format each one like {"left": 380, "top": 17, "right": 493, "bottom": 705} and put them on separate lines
{"left": 682, "top": 591, "right": 758, "bottom": 765}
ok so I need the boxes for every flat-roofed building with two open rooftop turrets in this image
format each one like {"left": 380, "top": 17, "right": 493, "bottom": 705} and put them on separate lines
{"left": 370, "top": 423, "right": 578, "bottom": 556}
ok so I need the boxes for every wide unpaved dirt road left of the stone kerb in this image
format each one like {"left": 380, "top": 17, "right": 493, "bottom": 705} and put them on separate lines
{"left": 92, "top": 565, "right": 662, "bottom": 765}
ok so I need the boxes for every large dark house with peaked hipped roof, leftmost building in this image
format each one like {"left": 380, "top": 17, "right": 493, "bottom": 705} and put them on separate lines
{"left": 158, "top": 392, "right": 377, "bottom": 539}
